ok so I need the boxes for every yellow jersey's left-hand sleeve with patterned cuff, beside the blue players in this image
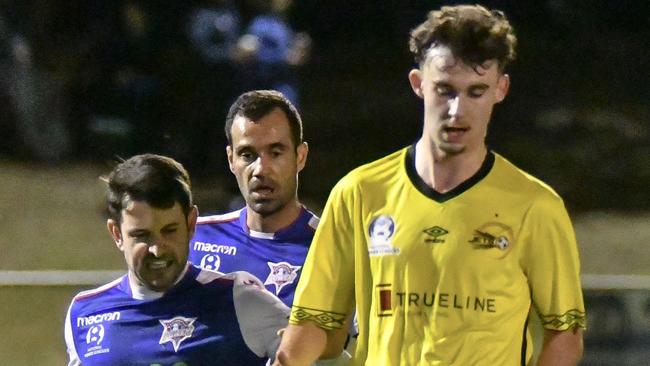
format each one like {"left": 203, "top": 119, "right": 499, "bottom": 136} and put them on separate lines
{"left": 290, "top": 178, "right": 356, "bottom": 330}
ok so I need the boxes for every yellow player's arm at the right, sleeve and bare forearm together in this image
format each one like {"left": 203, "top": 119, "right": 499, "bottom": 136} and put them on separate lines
{"left": 522, "top": 199, "right": 586, "bottom": 365}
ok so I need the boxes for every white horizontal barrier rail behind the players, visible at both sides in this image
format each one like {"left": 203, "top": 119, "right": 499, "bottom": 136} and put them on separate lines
{"left": 0, "top": 271, "right": 650, "bottom": 290}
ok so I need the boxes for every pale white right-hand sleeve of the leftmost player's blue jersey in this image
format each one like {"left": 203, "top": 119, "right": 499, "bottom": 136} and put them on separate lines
{"left": 233, "top": 272, "right": 290, "bottom": 358}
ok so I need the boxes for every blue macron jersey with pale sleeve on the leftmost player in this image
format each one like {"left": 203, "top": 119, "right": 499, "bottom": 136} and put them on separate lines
{"left": 65, "top": 265, "right": 289, "bottom": 366}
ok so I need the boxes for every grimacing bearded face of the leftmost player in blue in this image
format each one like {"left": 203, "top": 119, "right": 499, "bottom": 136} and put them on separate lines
{"left": 107, "top": 201, "right": 198, "bottom": 292}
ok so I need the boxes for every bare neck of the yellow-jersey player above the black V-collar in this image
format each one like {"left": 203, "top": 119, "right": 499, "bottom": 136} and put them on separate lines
{"left": 415, "top": 139, "right": 487, "bottom": 193}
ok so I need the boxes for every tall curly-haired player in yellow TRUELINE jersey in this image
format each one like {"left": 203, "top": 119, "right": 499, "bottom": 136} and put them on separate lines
{"left": 276, "top": 5, "right": 585, "bottom": 366}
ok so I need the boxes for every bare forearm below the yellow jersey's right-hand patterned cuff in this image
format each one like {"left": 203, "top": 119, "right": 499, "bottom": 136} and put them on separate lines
{"left": 537, "top": 327, "right": 582, "bottom": 366}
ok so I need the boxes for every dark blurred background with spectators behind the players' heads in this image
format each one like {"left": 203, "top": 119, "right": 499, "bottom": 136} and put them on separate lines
{"left": 0, "top": 0, "right": 650, "bottom": 210}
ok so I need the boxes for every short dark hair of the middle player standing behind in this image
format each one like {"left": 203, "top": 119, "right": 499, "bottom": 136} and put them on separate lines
{"left": 225, "top": 90, "right": 302, "bottom": 148}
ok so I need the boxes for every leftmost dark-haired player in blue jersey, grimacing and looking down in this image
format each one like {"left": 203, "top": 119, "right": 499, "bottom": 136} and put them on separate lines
{"left": 65, "top": 154, "right": 289, "bottom": 365}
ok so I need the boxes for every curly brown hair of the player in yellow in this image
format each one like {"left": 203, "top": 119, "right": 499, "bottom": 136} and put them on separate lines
{"left": 409, "top": 5, "right": 517, "bottom": 71}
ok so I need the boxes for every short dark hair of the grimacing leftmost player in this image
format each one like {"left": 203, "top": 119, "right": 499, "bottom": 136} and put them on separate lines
{"left": 105, "top": 154, "right": 192, "bottom": 222}
